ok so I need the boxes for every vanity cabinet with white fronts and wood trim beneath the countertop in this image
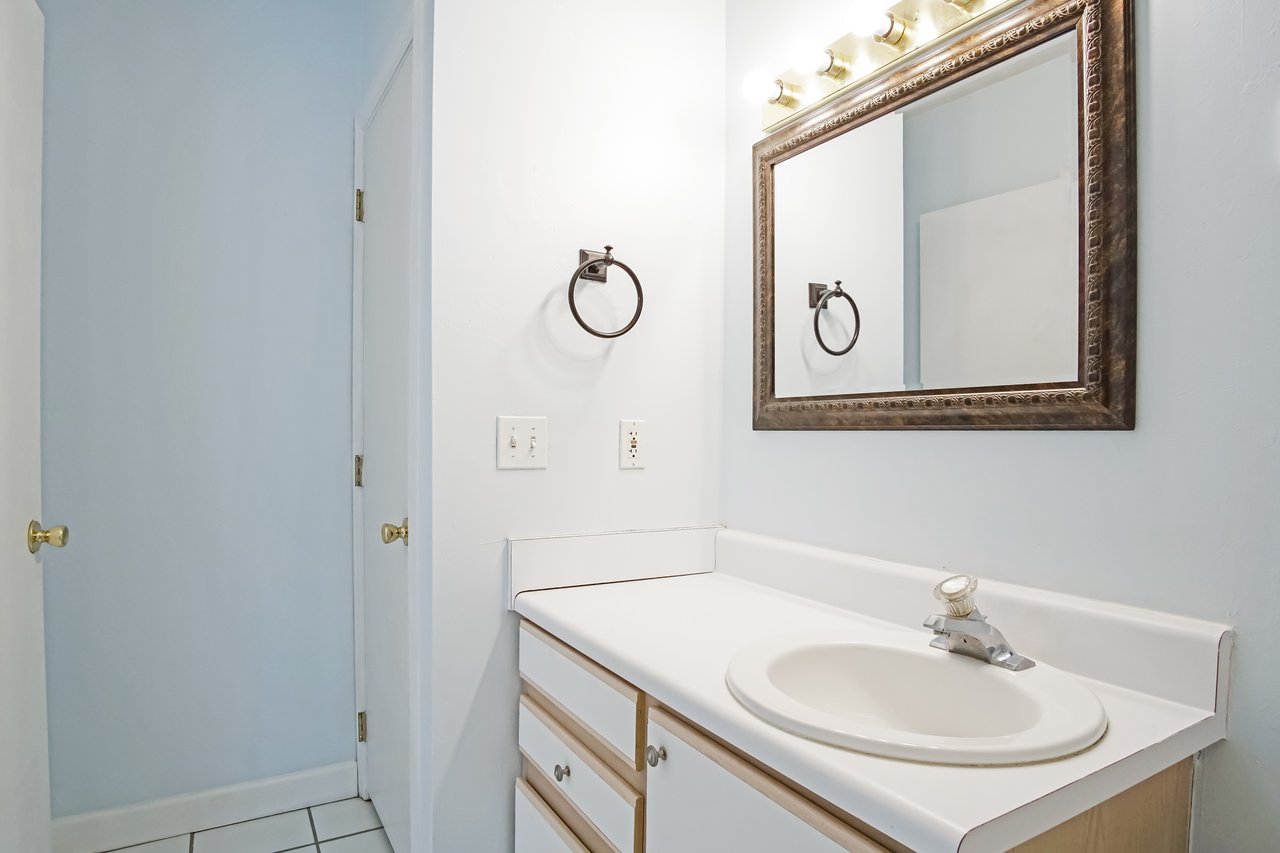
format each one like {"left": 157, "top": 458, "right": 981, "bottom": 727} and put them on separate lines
{"left": 515, "top": 621, "right": 1192, "bottom": 853}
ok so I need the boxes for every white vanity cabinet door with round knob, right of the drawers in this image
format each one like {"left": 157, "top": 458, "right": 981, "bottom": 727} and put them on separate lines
{"left": 645, "top": 708, "right": 884, "bottom": 853}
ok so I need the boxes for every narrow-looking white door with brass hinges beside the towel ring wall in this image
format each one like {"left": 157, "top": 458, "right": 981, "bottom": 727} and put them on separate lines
{"left": 357, "top": 58, "right": 413, "bottom": 853}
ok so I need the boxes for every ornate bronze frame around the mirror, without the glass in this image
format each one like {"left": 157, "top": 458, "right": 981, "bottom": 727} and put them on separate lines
{"left": 753, "top": 0, "right": 1137, "bottom": 429}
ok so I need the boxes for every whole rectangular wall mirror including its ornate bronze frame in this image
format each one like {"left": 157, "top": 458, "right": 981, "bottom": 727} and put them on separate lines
{"left": 755, "top": 0, "right": 1135, "bottom": 429}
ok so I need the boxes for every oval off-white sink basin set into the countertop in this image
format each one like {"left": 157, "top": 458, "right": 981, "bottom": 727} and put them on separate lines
{"left": 727, "top": 635, "right": 1107, "bottom": 765}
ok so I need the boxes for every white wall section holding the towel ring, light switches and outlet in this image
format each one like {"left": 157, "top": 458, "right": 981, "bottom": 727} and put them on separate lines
{"left": 424, "top": 0, "right": 724, "bottom": 853}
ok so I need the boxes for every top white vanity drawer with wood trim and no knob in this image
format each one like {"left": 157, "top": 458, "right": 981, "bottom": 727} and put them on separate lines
{"left": 520, "top": 622, "right": 644, "bottom": 770}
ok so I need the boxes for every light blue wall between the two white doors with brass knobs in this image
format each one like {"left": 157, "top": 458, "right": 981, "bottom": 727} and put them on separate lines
{"left": 42, "top": 0, "right": 365, "bottom": 816}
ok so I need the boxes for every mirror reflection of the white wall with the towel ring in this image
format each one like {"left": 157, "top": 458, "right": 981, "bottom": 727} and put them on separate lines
{"left": 773, "top": 114, "right": 904, "bottom": 397}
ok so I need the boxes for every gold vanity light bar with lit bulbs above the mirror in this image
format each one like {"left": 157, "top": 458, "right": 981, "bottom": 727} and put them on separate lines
{"left": 762, "top": 0, "right": 1025, "bottom": 131}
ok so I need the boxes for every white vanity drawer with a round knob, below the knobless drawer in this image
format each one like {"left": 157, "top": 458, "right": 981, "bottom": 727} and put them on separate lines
{"left": 520, "top": 695, "right": 644, "bottom": 853}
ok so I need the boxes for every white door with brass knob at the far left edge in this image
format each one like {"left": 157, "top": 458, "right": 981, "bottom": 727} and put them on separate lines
{"left": 0, "top": 0, "right": 49, "bottom": 853}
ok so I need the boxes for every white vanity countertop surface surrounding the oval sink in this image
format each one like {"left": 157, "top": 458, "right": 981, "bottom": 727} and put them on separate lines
{"left": 515, "top": 573, "right": 1225, "bottom": 853}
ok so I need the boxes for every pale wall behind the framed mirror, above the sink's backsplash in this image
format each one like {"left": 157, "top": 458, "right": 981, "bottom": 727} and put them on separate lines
{"left": 722, "top": 0, "right": 1280, "bottom": 852}
